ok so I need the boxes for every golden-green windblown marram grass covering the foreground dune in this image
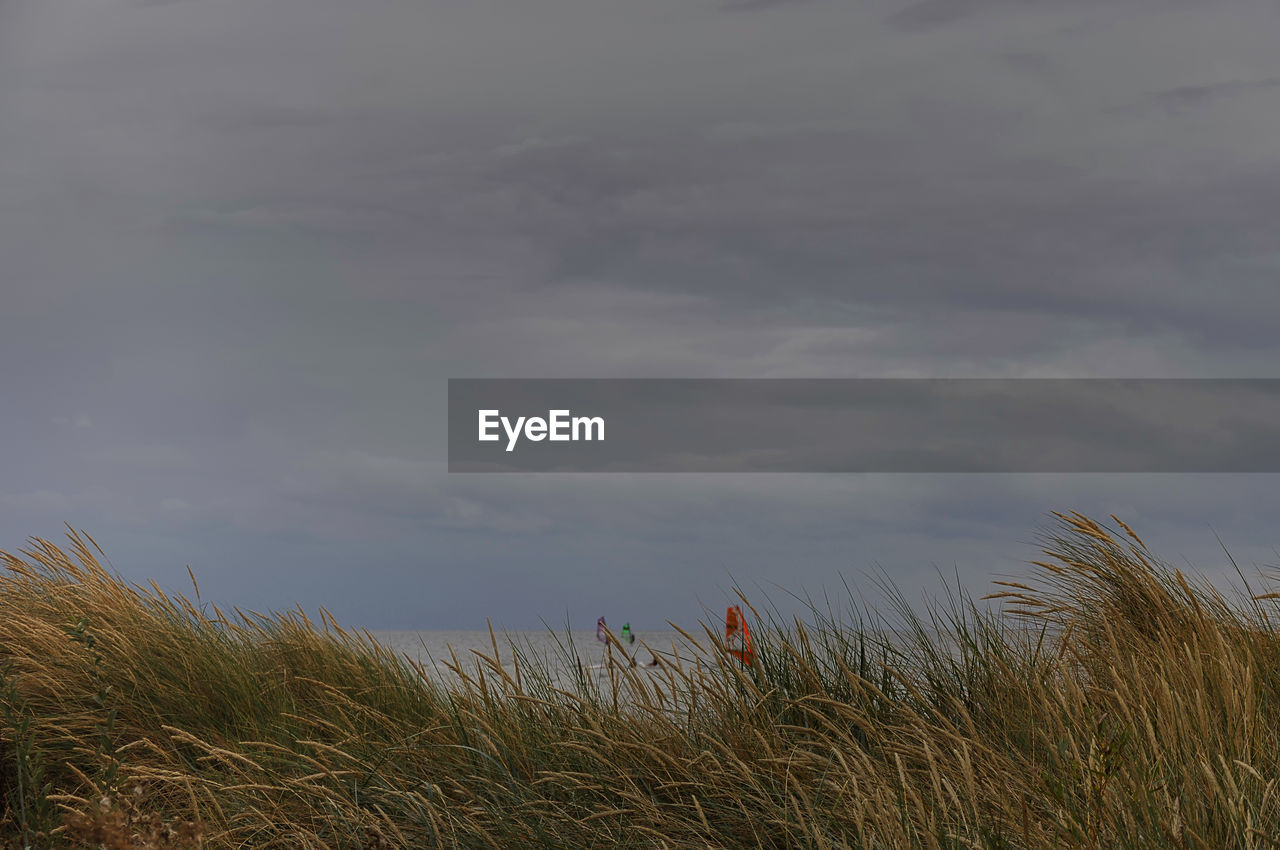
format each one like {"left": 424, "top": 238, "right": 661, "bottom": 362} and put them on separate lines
{"left": 0, "top": 515, "right": 1280, "bottom": 849}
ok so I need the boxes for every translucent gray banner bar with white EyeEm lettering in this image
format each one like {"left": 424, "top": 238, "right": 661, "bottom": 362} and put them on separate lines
{"left": 449, "top": 379, "right": 1280, "bottom": 472}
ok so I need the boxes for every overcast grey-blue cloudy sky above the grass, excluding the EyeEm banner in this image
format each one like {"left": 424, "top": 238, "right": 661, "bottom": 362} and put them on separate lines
{"left": 0, "top": 0, "right": 1280, "bottom": 629}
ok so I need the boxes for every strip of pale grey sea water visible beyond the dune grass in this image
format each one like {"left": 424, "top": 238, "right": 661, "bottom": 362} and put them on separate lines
{"left": 369, "top": 630, "right": 703, "bottom": 681}
